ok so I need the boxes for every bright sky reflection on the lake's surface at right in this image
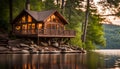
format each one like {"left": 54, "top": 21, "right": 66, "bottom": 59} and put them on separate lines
{"left": 95, "top": 49, "right": 120, "bottom": 69}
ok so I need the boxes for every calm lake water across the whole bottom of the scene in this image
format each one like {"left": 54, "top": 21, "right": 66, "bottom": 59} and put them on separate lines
{"left": 0, "top": 51, "right": 120, "bottom": 69}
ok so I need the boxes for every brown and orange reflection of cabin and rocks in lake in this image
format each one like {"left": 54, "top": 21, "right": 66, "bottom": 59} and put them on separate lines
{"left": 0, "top": 54, "right": 87, "bottom": 69}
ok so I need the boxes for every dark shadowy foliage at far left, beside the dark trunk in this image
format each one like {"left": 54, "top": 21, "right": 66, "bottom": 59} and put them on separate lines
{"left": 0, "top": 0, "right": 10, "bottom": 32}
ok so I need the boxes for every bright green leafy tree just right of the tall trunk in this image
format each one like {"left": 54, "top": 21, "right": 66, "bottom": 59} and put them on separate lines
{"left": 85, "top": 15, "right": 106, "bottom": 49}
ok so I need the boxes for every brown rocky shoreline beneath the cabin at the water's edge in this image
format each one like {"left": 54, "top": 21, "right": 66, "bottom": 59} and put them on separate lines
{"left": 0, "top": 34, "right": 86, "bottom": 54}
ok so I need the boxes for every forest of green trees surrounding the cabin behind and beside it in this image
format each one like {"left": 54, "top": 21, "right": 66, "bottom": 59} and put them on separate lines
{"left": 0, "top": 0, "right": 120, "bottom": 49}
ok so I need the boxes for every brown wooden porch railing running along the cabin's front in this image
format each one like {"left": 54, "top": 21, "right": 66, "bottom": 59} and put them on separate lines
{"left": 15, "top": 29, "right": 76, "bottom": 36}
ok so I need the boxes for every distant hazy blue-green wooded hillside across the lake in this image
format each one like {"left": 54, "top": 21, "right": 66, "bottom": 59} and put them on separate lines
{"left": 101, "top": 24, "right": 120, "bottom": 49}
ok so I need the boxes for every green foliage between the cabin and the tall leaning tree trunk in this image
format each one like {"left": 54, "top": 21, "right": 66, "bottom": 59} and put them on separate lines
{"left": 61, "top": 0, "right": 84, "bottom": 47}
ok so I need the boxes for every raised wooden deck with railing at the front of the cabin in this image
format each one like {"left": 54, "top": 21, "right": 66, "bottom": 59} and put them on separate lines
{"left": 15, "top": 29, "right": 76, "bottom": 37}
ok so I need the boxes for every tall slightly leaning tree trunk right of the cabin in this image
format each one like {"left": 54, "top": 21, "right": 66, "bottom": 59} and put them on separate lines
{"left": 82, "top": 0, "right": 89, "bottom": 43}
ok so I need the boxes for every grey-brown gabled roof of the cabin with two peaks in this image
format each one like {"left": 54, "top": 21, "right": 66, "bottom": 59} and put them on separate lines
{"left": 13, "top": 10, "right": 68, "bottom": 24}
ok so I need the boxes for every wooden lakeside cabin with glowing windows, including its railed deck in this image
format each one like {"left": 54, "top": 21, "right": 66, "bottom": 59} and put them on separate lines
{"left": 13, "top": 10, "right": 75, "bottom": 38}
